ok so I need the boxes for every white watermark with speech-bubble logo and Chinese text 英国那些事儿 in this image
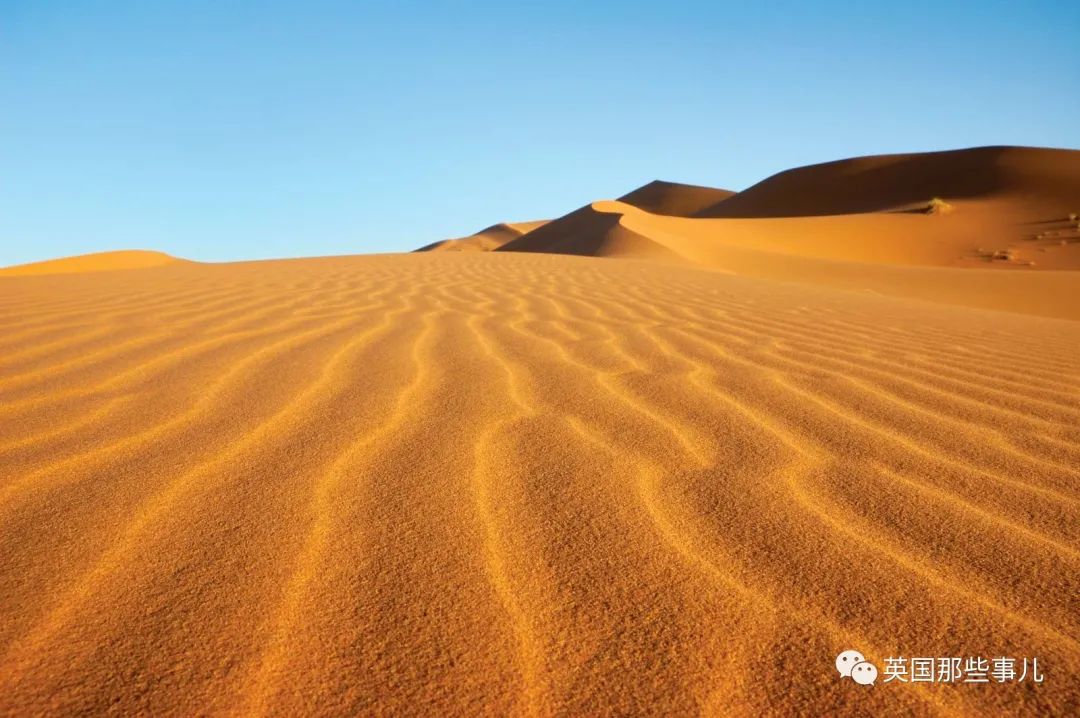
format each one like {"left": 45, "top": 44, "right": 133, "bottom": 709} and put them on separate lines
{"left": 836, "top": 650, "right": 1045, "bottom": 686}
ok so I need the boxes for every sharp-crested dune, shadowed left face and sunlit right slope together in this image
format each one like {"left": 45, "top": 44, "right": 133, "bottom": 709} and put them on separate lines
{"left": 498, "top": 201, "right": 1080, "bottom": 319}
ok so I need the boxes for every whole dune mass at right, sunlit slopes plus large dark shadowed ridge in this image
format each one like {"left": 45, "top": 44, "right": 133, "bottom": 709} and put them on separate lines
{"left": 500, "top": 148, "right": 1080, "bottom": 317}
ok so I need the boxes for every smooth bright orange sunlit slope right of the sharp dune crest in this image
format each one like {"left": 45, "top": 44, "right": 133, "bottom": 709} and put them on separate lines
{"left": 619, "top": 199, "right": 1080, "bottom": 319}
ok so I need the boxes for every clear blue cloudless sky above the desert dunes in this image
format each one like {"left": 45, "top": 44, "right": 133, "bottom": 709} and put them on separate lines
{"left": 0, "top": 0, "right": 1080, "bottom": 265}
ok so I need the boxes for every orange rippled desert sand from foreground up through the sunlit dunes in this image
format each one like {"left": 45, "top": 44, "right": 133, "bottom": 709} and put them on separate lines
{"left": 0, "top": 142, "right": 1080, "bottom": 716}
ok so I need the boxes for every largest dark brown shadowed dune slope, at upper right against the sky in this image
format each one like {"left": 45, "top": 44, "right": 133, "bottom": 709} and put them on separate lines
{"left": 699, "top": 142, "right": 1080, "bottom": 219}
